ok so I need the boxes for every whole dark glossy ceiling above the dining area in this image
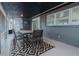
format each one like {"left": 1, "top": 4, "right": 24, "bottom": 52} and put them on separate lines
{"left": 2, "top": 2, "right": 72, "bottom": 18}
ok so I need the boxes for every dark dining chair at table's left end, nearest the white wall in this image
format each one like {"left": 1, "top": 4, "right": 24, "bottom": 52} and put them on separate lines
{"left": 13, "top": 29, "right": 23, "bottom": 50}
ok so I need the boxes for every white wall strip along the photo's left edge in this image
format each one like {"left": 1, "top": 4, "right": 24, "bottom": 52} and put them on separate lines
{"left": 0, "top": 3, "right": 6, "bottom": 55}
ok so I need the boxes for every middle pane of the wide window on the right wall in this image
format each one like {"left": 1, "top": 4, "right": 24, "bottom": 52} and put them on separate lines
{"left": 56, "top": 10, "right": 69, "bottom": 25}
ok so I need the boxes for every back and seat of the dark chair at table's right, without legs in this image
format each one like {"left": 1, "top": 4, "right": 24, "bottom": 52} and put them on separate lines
{"left": 28, "top": 30, "right": 43, "bottom": 43}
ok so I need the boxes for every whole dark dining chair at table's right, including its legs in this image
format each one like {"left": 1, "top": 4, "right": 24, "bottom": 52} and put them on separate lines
{"left": 26, "top": 30, "right": 43, "bottom": 50}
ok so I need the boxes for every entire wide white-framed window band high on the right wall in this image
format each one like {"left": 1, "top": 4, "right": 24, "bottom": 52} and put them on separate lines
{"left": 46, "top": 6, "right": 79, "bottom": 26}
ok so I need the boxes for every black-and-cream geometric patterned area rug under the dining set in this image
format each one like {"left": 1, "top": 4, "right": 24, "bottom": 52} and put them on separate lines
{"left": 10, "top": 42, "right": 54, "bottom": 56}
